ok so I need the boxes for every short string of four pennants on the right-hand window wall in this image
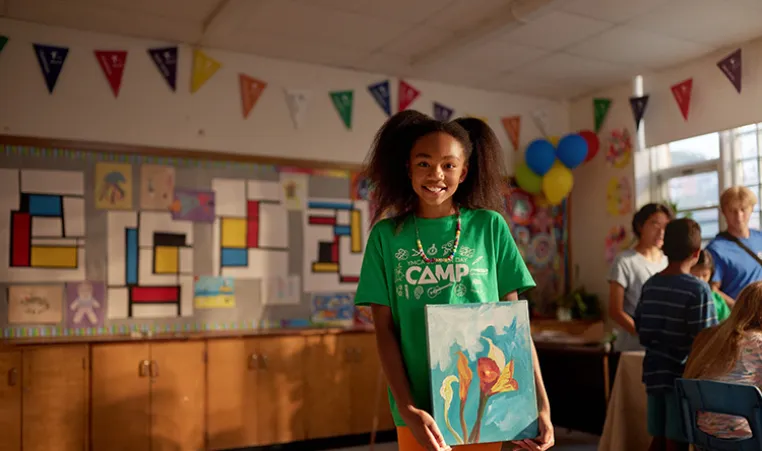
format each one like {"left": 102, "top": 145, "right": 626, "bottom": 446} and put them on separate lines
{"left": 593, "top": 48, "right": 743, "bottom": 133}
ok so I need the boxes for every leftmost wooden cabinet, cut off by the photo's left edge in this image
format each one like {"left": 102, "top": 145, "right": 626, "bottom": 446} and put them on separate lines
{"left": 0, "top": 345, "right": 88, "bottom": 451}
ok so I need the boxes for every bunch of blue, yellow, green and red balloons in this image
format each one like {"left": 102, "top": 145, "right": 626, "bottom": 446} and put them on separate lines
{"left": 516, "top": 130, "right": 600, "bottom": 205}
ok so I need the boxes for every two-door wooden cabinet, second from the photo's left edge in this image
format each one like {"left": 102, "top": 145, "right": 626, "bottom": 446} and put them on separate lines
{"left": 91, "top": 341, "right": 206, "bottom": 451}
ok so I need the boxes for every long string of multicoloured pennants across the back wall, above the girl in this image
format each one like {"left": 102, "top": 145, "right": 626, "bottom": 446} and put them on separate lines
{"left": 0, "top": 35, "right": 521, "bottom": 147}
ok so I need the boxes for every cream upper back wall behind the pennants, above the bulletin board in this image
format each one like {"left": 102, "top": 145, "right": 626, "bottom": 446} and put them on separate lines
{"left": 0, "top": 19, "right": 569, "bottom": 168}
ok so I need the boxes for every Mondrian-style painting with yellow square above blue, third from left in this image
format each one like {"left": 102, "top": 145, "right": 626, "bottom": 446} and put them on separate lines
{"left": 212, "top": 179, "right": 288, "bottom": 279}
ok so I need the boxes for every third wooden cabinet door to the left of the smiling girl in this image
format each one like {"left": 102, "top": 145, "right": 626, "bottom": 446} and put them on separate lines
{"left": 255, "top": 336, "right": 310, "bottom": 445}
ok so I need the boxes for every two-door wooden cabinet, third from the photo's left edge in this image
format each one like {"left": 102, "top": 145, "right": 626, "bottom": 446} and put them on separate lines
{"left": 207, "top": 336, "right": 306, "bottom": 449}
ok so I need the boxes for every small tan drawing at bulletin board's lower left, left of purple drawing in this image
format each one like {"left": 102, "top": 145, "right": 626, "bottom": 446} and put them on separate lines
{"left": 8, "top": 285, "right": 63, "bottom": 324}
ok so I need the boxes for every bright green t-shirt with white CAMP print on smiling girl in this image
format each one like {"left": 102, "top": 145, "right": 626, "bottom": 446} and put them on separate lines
{"left": 355, "top": 209, "right": 535, "bottom": 426}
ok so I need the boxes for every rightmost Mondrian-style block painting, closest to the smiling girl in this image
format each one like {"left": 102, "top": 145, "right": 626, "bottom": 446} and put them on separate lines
{"left": 303, "top": 199, "right": 370, "bottom": 292}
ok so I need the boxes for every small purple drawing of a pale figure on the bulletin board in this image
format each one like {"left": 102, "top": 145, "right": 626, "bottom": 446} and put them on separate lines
{"left": 66, "top": 281, "right": 108, "bottom": 329}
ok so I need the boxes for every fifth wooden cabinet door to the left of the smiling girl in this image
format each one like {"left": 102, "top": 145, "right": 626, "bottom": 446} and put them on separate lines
{"left": 151, "top": 340, "right": 206, "bottom": 451}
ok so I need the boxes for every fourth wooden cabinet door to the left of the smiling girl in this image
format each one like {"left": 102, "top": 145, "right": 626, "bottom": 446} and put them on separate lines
{"left": 206, "top": 338, "right": 258, "bottom": 450}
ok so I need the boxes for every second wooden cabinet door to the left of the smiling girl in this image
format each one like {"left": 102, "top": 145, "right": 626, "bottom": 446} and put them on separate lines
{"left": 305, "top": 334, "right": 352, "bottom": 439}
